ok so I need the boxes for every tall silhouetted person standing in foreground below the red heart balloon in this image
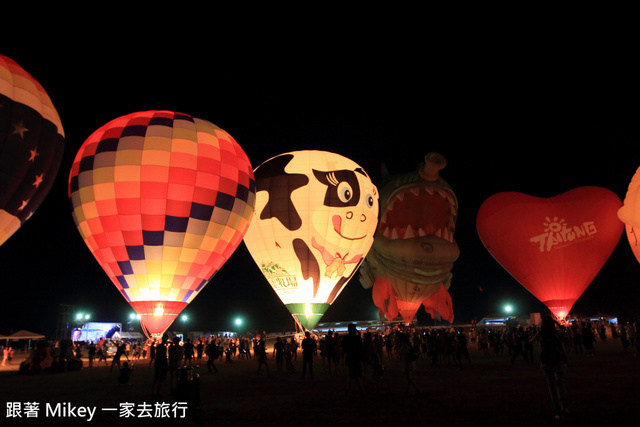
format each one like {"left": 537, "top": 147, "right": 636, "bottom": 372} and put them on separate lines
{"left": 531, "top": 316, "right": 568, "bottom": 420}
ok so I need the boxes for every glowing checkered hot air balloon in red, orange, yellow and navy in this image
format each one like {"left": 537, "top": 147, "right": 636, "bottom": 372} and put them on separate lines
{"left": 69, "top": 111, "right": 255, "bottom": 335}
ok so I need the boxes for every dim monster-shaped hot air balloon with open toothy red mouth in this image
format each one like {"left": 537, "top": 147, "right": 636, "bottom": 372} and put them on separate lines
{"left": 360, "top": 153, "right": 460, "bottom": 324}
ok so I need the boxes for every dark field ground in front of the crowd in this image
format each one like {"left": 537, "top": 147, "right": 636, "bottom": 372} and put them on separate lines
{"left": 0, "top": 340, "right": 640, "bottom": 427}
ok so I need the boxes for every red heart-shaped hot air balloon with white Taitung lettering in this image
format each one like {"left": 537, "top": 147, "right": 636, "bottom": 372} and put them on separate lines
{"left": 476, "top": 187, "right": 623, "bottom": 320}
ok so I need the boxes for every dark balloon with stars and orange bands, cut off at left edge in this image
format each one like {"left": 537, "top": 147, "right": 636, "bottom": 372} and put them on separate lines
{"left": 0, "top": 55, "right": 64, "bottom": 245}
